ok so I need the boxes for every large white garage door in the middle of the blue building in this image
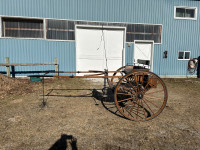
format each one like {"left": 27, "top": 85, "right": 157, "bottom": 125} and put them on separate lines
{"left": 76, "top": 28, "right": 124, "bottom": 74}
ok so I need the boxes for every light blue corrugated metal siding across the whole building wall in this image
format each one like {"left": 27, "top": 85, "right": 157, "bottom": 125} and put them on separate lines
{"left": 0, "top": 0, "right": 200, "bottom": 75}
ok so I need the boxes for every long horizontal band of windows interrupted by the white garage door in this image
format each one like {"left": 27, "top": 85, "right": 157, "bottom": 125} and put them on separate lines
{"left": 0, "top": 17, "right": 162, "bottom": 44}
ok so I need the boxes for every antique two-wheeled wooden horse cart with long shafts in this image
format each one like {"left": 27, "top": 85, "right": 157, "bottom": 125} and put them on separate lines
{"left": 31, "top": 66, "right": 168, "bottom": 121}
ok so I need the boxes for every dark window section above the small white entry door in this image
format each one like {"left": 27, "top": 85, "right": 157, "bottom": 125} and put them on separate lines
{"left": 126, "top": 24, "right": 162, "bottom": 43}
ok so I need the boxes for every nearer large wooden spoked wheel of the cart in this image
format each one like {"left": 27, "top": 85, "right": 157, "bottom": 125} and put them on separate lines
{"left": 114, "top": 71, "right": 168, "bottom": 121}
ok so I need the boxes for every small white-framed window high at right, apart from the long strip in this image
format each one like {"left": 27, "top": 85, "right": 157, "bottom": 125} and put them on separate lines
{"left": 174, "top": 6, "right": 197, "bottom": 20}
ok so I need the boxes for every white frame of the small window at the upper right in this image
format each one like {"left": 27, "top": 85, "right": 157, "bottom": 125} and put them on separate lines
{"left": 174, "top": 6, "right": 197, "bottom": 20}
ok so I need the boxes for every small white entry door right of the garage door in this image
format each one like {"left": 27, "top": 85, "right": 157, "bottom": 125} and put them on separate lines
{"left": 134, "top": 42, "right": 153, "bottom": 71}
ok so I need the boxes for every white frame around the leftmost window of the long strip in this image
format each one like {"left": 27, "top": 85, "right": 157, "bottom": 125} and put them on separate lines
{"left": 0, "top": 16, "right": 45, "bottom": 40}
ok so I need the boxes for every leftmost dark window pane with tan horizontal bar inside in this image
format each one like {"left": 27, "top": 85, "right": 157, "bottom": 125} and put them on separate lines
{"left": 2, "top": 18, "right": 44, "bottom": 38}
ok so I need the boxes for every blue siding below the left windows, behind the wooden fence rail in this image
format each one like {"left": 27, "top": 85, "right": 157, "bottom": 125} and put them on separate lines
{"left": 0, "top": 39, "right": 76, "bottom": 75}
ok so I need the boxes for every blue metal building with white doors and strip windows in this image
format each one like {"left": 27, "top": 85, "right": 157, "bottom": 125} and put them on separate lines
{"left": 0, "top": 0, "right": 200, "bottom": 77}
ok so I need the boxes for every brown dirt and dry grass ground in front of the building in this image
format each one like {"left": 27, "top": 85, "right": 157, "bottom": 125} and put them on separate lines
{"left": 0, "top": 75, "right": 200, "bottom": 150}
